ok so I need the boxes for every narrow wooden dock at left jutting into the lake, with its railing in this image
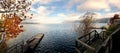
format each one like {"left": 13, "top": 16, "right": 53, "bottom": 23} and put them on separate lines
{"left": 3, "top": 33, "right": 44, "bottom": 53}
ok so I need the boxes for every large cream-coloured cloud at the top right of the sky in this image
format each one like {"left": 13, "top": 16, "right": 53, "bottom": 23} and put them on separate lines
{"left": 77, "top": 0, "right": 120, "bottom": 12}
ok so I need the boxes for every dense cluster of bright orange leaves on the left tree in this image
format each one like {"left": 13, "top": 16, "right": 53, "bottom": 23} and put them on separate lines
{"left": 0, "top": 14, "right": 23, "bottom": 39}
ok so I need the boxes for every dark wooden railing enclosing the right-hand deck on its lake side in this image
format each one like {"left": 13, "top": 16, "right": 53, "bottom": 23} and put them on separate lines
{"left": 75, "top": 30, "right": 105, "bottom": 53}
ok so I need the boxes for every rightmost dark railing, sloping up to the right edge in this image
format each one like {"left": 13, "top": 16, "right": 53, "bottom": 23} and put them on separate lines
{"left": 99, "top": 27, "right": 120, "bottom": 53}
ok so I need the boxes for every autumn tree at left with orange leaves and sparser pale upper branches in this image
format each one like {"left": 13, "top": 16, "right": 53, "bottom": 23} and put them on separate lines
{"left": 0, "top": 0, "right": 33, "bottom": 40}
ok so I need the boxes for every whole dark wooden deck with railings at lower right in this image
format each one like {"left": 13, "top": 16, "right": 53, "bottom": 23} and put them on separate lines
{"left": 75, "top": 27, "right": 120, "bottom": 53}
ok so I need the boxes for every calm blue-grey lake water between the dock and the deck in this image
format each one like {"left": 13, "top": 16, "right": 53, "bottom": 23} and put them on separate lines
{"left": 8, "top": 23, "right": 106, "bottom": 53}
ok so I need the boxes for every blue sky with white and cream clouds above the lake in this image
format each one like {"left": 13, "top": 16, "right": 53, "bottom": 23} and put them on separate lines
{"left": 26, "top": 0, "right": 120, "bottom": 24}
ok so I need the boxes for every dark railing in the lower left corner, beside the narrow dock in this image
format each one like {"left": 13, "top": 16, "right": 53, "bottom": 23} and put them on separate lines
{"left": 0, "top": 40, "right": 29, "bottom": 53}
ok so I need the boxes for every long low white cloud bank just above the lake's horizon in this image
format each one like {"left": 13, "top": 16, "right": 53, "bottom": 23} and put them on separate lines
{"left": 26, "top": 13, "right": 81, "bottom": 24}
